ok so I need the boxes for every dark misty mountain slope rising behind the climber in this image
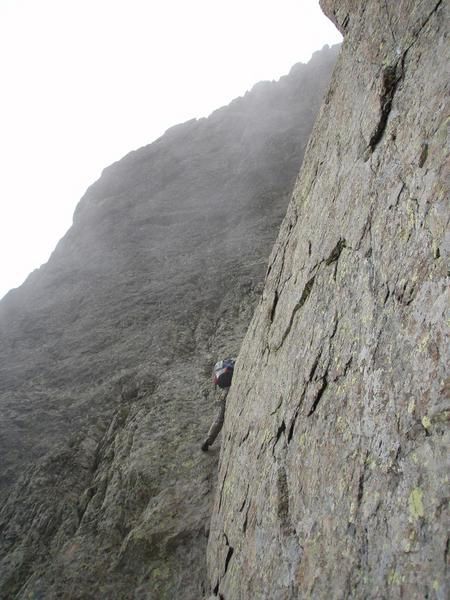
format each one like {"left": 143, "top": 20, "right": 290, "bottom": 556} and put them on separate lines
{"left": 0, "top": 48, "right": 338, "bottom": 600}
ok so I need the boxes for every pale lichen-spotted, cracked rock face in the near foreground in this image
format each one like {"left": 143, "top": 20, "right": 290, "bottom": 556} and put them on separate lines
{"left": 208, "top": 0, "right": 450, "bottom": 600}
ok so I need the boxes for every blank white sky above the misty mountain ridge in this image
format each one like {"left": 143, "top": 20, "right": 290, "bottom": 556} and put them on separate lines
{"left": 0, "top": 0, "right": 341, "bottom": 298}
